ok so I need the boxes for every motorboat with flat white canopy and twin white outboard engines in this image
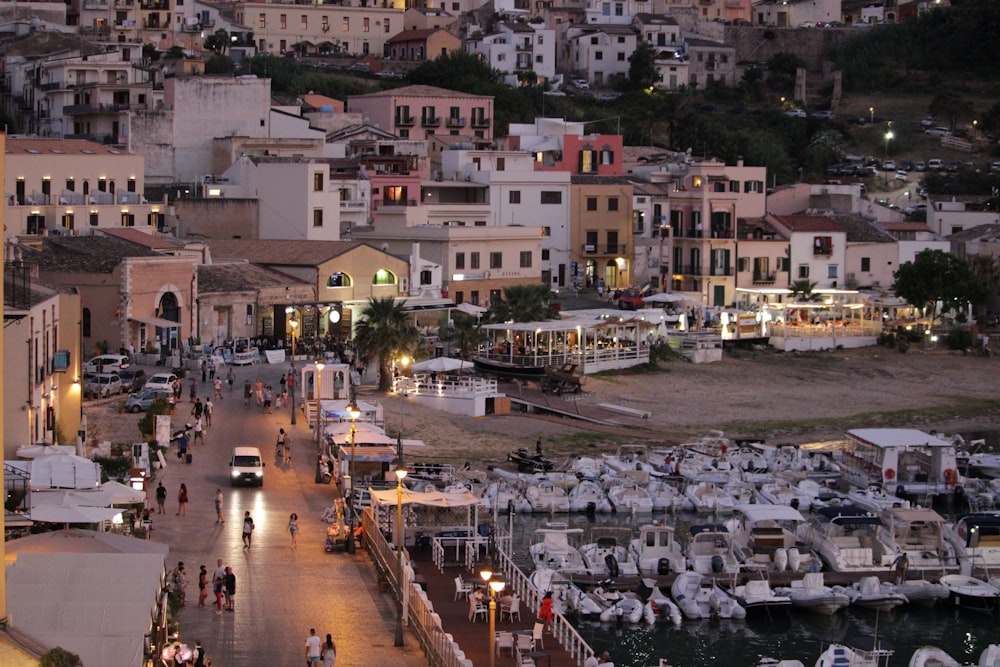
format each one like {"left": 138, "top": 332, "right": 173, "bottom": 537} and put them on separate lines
{"left": 726, "top": 505, "right": 816, "bottom": 572}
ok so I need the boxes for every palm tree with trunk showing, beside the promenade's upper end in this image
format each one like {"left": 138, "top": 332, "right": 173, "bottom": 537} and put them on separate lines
{"left": 354, "top": 296, "right": 420, "bottom": 391}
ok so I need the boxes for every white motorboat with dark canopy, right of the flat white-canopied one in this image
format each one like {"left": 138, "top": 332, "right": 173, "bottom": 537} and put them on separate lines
{"left": 798, "top": 505, "right": 896, "bottom": 572}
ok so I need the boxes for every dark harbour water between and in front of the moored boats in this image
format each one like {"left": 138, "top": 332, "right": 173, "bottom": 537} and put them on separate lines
{"left": 513, "top": 431, "right": 1000, "bottom": 667}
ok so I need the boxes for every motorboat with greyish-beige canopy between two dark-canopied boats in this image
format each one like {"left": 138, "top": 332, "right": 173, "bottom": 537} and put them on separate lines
{"left": 878, "top": 507, "right": 958, "bottom": 574}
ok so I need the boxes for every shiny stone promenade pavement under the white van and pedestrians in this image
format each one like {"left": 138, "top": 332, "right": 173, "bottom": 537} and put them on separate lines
{"left": 149, "top": 364, "right": 428, "bottom": 667}
